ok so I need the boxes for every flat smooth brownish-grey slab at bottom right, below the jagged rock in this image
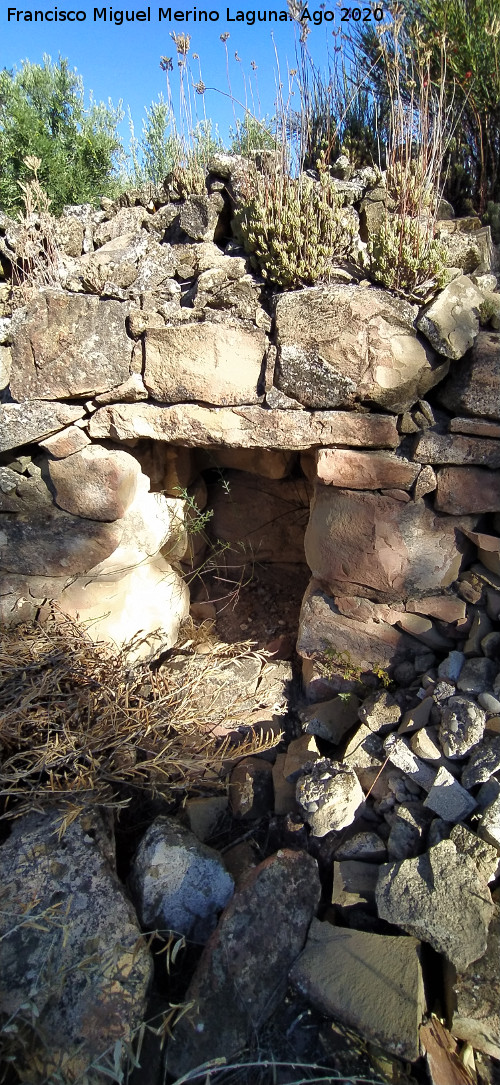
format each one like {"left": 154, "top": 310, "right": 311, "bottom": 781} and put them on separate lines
{"left": 290, "top": 919, "right": 425, "bottom": 1061}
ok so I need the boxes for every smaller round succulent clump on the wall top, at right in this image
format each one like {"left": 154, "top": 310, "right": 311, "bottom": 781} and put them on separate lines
{"left": 369, "top": 215, "right": 446, "bottom": 302}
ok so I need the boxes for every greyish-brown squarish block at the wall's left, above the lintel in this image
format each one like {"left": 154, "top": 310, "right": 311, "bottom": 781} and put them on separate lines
{"left": 11, "top": 290, "right": 132, "bottom": 401}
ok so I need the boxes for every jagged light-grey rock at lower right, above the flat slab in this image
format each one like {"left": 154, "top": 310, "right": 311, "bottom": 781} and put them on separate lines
{"left": 376, "top": 840, "right": 493, "bottom": 971}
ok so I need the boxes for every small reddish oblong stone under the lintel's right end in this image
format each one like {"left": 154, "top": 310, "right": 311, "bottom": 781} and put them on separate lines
{"left": 316, "top": 448, "right": 416, "bottom": 489}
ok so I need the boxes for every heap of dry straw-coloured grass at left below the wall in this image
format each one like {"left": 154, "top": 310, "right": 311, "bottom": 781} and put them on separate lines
{"left": 0, "top": 613, "right": 275, "bottom": 818}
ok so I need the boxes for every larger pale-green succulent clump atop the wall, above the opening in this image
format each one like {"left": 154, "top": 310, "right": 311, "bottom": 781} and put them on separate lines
{"left": 233, "top": 164, "right": 354, "bottom": 289}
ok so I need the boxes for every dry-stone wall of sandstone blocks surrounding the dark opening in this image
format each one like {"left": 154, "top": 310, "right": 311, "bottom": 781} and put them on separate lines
{"left": 0, "top": 156, "right": 500, "bottom": 677}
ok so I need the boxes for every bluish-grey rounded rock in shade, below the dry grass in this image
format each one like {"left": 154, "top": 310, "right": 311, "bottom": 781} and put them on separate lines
{"left": 130, "top": 817, "right": 234, "bottom": 943}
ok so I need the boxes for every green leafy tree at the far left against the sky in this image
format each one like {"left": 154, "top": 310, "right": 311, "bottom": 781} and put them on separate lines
{"left": 0, "top": 56, "right": 123, "bottom": 214}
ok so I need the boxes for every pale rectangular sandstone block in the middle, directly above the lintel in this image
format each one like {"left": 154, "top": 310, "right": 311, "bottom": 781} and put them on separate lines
{"left": 144, "top": 322, "right": 267, "bottom": 407}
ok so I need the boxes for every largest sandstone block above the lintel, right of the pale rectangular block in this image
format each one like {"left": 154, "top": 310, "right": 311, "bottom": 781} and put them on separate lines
{"left": 275, "top": 285, "right": 447, "bottom": 411}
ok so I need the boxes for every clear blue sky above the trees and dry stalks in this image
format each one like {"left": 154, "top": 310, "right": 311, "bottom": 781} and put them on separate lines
{"left": 0, "top": 0, "right": 350, "bottom": 160}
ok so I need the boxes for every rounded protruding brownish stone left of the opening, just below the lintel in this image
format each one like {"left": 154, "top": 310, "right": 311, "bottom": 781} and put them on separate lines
{"left": 49, "top": 445, "right": 141, "bottom": 521}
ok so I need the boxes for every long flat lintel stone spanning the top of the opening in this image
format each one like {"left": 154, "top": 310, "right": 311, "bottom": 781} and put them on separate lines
{"left": 89, "top": 404, "right": 400, "bottom": 450}
